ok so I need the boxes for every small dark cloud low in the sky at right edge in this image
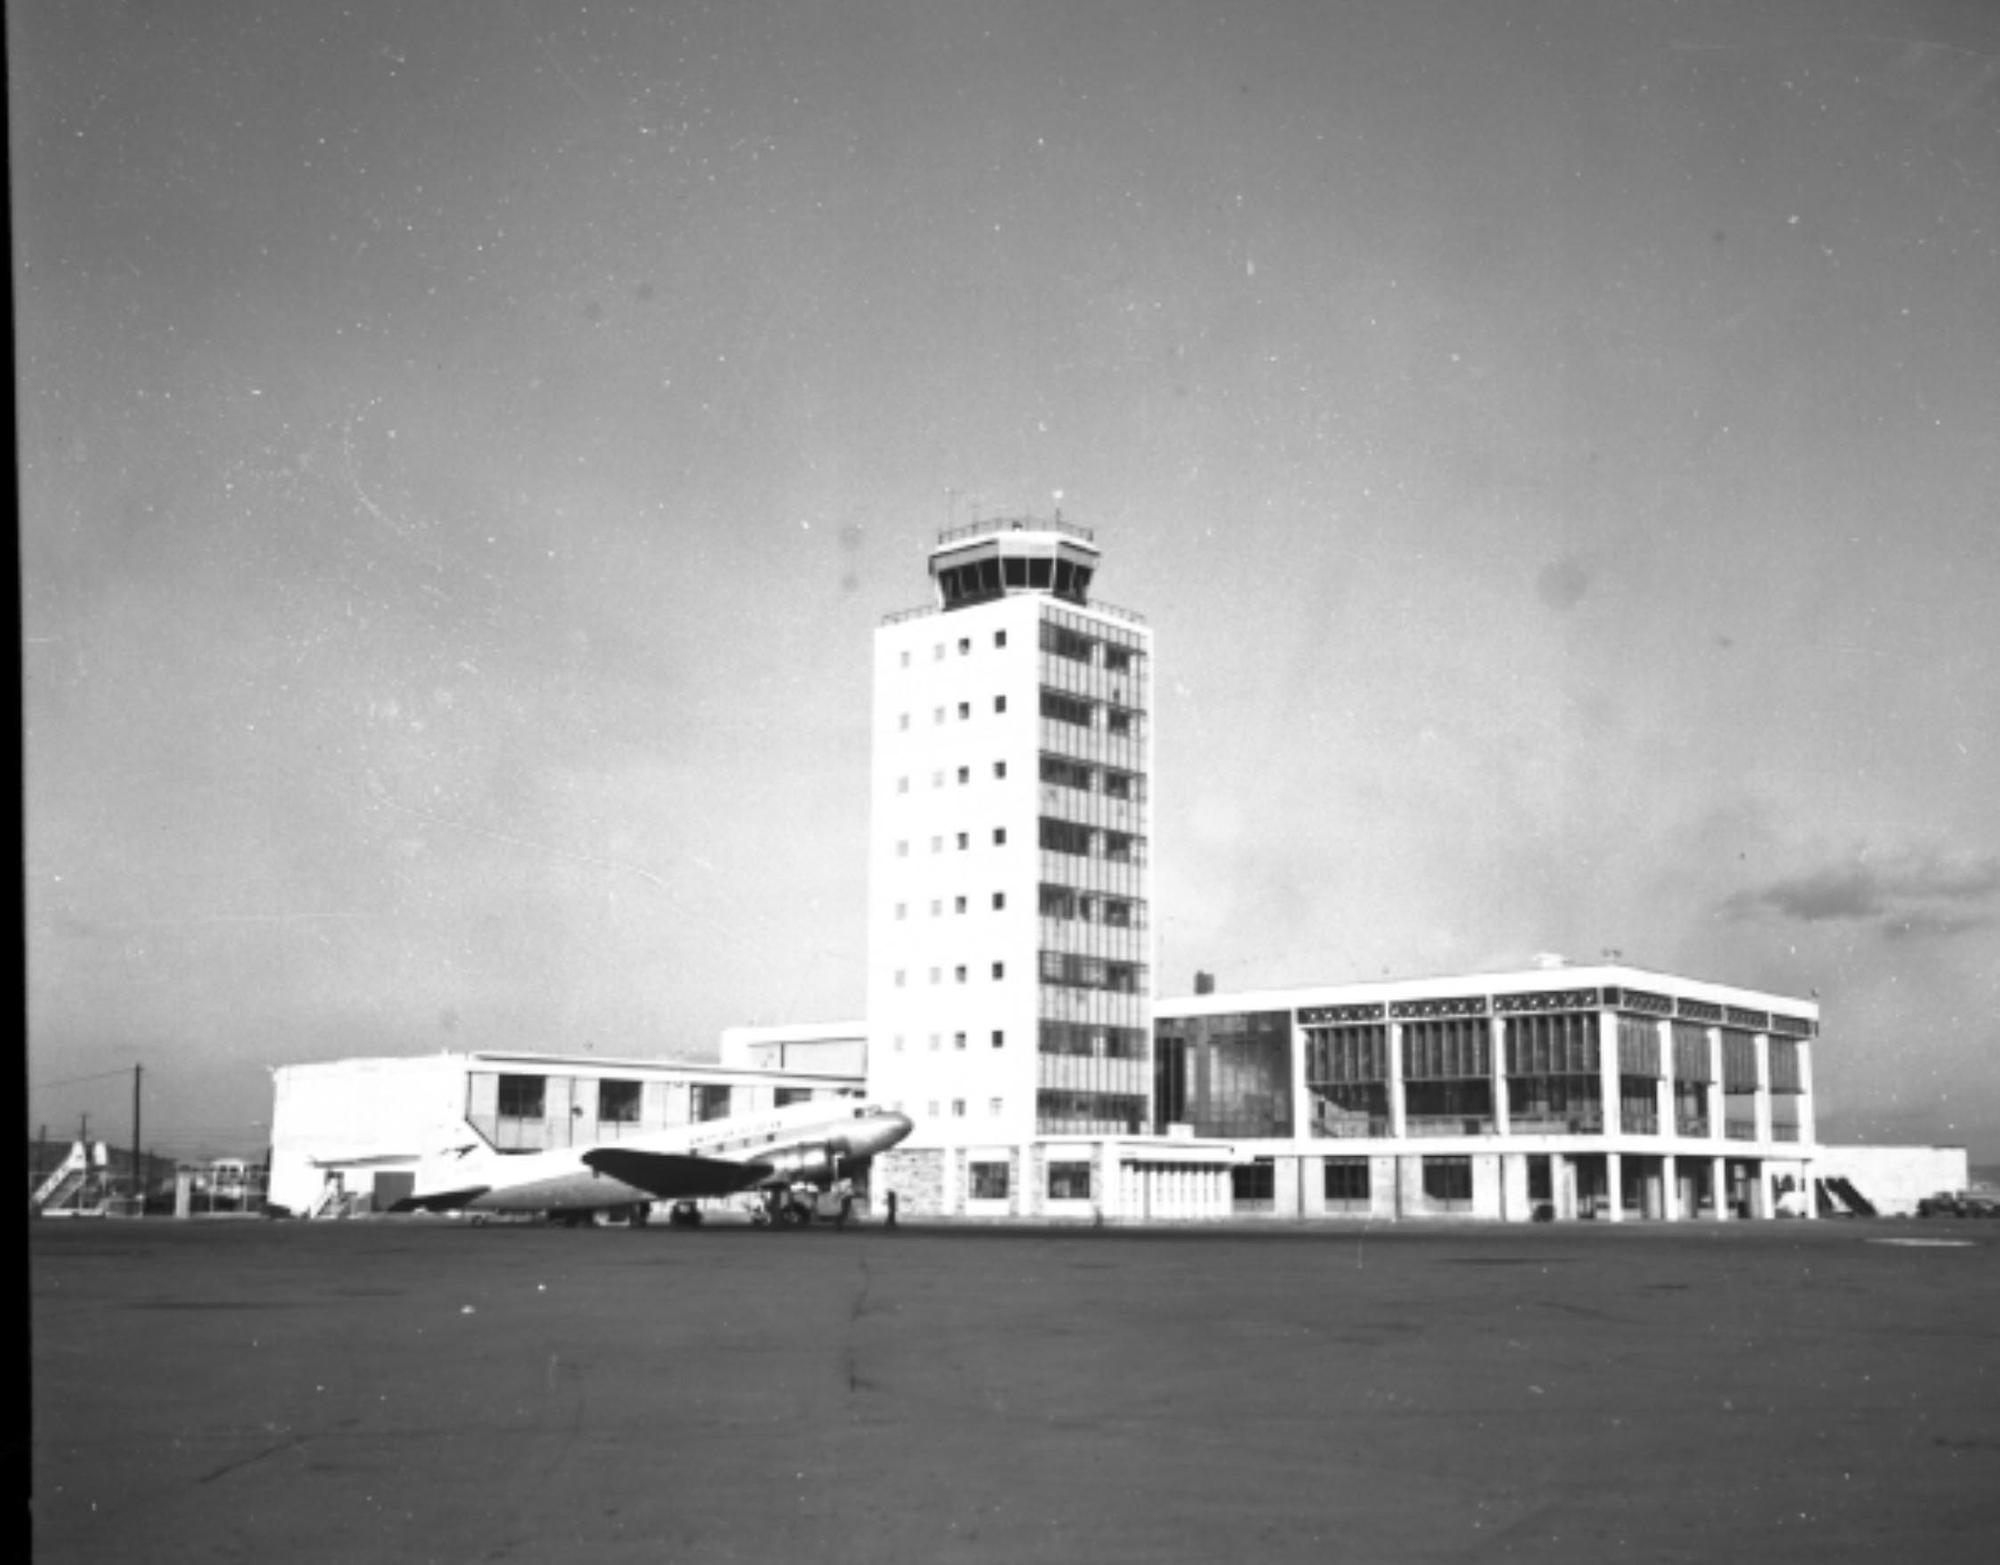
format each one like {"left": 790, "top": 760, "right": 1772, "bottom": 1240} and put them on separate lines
{"left": 1720, "top": 849, "right": 2000, "bottom": 941}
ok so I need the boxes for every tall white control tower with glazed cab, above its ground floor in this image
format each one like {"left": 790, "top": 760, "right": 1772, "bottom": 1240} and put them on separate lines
{"left": 868, "top": 518, "right": 1154, "bottom": 1151}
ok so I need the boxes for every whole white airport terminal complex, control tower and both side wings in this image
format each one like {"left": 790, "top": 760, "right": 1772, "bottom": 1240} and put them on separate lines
{"left": 258, "top": 512, "right": 1966, "bottom": 1223}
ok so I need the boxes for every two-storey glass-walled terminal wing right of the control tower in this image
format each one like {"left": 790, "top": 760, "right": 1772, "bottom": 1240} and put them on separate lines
{"left": 1152, "top": 965, "right": 1820, "bottom": 1223}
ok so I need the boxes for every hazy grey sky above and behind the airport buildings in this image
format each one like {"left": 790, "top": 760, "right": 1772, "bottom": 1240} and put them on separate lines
{"left": 19, "top": 0, "right": 2000, "bottom": 1163}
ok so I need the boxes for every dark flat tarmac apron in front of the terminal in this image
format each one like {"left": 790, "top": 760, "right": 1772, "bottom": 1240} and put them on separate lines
{"left": 28, "top": 1219, "right": 2000, "bottom": 1565}
